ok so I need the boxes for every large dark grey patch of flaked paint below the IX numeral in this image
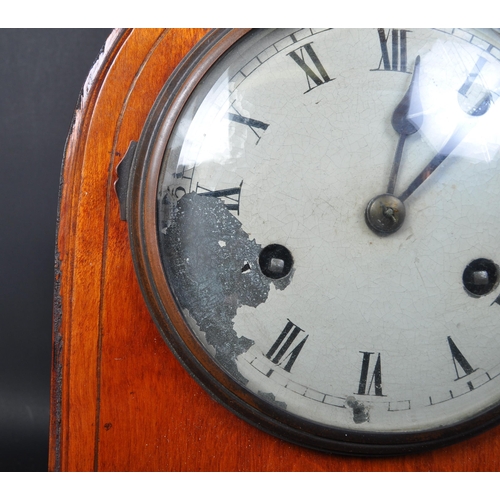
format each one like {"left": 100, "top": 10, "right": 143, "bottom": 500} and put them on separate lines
{"left": 162, "top": 193, "right": 291, "bottom": 384}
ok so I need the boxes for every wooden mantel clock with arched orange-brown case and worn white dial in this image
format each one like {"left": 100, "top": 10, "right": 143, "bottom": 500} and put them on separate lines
{"left": 51, "top": 28, "right": 500, "bottom": 470}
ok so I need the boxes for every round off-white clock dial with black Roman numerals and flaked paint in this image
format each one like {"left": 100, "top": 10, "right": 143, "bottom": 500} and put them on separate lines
{"left": 158, "top": 29, "right": 500, "bottom": 442}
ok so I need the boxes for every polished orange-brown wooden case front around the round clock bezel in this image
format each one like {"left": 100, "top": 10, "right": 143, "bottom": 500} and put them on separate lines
{"left": 49, "top": 29, "right": 500, "bottom": 471}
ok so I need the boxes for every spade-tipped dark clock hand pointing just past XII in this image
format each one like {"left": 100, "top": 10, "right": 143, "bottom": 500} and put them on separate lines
{"left": 387, "top": 56, "right": 423, "bottom": 194}
